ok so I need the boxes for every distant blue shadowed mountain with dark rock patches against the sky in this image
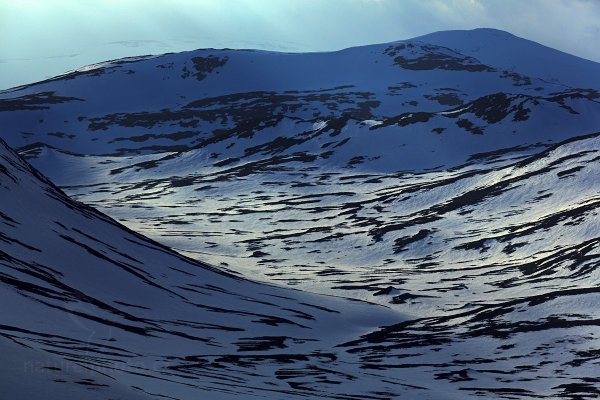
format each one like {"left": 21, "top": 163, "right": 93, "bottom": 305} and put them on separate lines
{"left": 0, "top": 30, "right": 600, "bottom": 172}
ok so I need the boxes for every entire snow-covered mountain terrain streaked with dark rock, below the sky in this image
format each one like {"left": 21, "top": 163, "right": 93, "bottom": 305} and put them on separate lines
{"left": 0, "top": 30, "right": 600, "bottom": 399}
